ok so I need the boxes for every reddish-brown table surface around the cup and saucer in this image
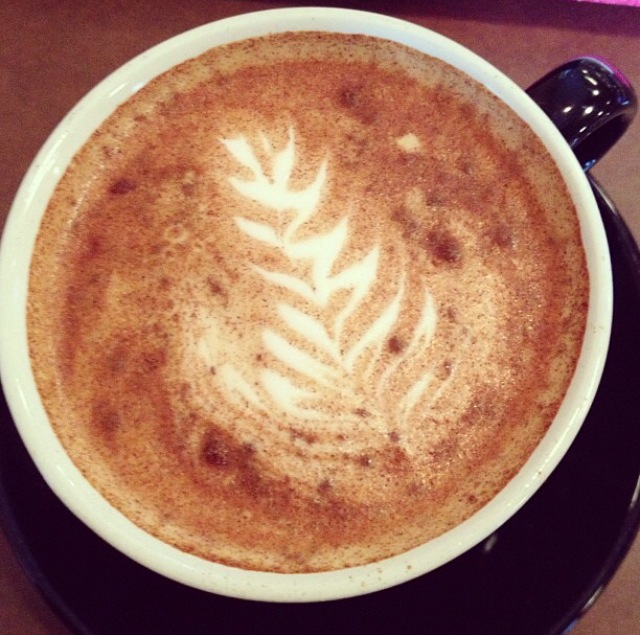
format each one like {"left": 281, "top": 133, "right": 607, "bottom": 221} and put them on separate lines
{"left": 0, "top": 0, "right": 640, "bottom": 635}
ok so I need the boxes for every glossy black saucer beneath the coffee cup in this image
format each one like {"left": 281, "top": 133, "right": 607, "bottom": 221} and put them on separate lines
{"left": 0, "top": 178, "right": 640, "bottom": 635}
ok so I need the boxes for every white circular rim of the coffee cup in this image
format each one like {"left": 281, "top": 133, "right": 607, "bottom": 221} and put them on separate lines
{"left": 0, "top": 7, "right": 613, "bottom": 602}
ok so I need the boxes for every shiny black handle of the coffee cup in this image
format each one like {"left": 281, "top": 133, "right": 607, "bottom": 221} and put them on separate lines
{"left": 526, "top": 57, "right": 637, "bottom": 172}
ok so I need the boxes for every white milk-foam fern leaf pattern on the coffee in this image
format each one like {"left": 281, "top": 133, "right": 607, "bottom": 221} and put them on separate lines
{"left": 215, "top": 128, "right": 437, "bottom": 428}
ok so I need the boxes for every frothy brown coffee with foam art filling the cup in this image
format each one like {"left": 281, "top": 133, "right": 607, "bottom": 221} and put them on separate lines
{"left": 28, "top": 33, "right": 588, "bottom": 572}
